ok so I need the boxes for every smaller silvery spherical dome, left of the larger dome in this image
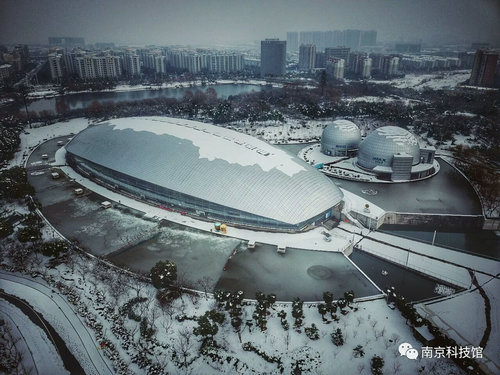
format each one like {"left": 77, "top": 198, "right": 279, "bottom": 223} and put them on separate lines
{"left": 321, "top": 120, "right": 361, "bottom": 156}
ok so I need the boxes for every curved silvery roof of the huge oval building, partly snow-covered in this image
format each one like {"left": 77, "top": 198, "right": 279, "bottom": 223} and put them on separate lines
{"left": 66, "top": 117, "right": 343, "bottom": 224}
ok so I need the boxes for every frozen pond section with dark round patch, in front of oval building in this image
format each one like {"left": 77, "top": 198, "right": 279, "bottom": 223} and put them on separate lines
{"left": 217, "top": 245, "right": 379, "bottom": 301}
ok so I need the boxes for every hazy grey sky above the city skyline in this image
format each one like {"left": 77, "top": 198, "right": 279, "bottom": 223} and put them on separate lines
{"left": 0, "top": 0, "right": 500, "bottom": 46}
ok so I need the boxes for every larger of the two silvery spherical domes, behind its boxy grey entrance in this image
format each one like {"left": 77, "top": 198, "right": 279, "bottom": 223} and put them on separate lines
{"left": 358, "top": 126, "right": 420, "bottom": 169}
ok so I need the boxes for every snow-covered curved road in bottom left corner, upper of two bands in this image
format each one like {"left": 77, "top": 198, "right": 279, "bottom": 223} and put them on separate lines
{"left": 0, "top": 271, "right": 114, "bottom": 375}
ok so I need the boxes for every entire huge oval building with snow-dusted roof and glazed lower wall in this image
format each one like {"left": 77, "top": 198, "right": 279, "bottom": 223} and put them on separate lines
{"left": 65, "top": 117, "right": 343, "bottom": 231}
